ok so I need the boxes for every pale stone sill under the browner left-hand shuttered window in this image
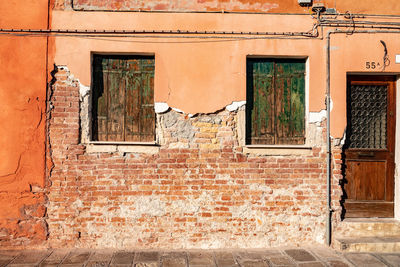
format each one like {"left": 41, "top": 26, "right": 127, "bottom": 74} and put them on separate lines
{"left": 86, "top": 141, "right": 160, "bottom": 154}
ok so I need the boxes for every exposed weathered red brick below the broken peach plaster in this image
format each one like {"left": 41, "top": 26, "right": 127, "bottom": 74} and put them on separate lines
{"left": 47, "top": 68, "right": 341, "bottom": 249}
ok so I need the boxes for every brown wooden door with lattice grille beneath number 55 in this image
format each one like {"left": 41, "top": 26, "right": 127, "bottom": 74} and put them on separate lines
{"left": 344, "top": 76, "right": 396, "bottom": 218}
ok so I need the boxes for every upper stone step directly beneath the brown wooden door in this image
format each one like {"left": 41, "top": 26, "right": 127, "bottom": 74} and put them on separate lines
{"left": 335, "top": 219, "right": 400, "bottom": 237}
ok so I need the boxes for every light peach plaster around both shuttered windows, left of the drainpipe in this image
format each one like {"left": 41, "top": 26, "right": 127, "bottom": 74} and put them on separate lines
{"left": 52, "top": 12, "right": 324, "bottom": 113}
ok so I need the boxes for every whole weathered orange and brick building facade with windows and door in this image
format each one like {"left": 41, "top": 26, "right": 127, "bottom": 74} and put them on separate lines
{"left": 0, "top": 0, "right": 400, "bottom": 249}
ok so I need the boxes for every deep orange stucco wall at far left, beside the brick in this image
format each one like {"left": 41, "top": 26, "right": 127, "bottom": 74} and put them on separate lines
{"left": 0, "top": 0, "right": 48, "bottom": 248}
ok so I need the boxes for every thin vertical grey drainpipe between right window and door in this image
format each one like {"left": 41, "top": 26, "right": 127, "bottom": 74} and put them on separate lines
{"left": 325, "top": 31, "right": 332, "bottom": 246}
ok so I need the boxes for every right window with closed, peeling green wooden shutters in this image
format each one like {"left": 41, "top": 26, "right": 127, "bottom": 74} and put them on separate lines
{"left": 246, "top": 58, "right": 305, "bottom": 145}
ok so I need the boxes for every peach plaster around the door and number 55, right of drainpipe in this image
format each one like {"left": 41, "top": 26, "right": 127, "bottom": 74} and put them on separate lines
{"left": 331, "top": 33, "right": 400, "bottom": 137}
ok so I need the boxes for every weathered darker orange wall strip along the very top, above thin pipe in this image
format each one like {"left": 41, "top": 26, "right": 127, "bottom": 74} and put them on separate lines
{"left": 65, "top": 0, "right": 400, "bottom": 14}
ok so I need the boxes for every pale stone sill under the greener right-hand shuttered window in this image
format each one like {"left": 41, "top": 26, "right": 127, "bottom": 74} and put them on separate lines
{"left": 243, "top": 145, "right": 312, "bottom": 156}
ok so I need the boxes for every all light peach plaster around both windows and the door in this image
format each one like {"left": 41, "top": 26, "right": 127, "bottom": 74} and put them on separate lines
{"left": 52, "top": 9, "right": 400, "bottom": 138}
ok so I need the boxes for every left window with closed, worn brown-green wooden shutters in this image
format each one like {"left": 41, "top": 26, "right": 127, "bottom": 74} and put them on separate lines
{"left": 92, "top": 55, "right": 155, "bottom": 142}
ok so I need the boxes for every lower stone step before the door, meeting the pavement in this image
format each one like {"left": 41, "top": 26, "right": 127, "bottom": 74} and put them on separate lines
{"left": 336, "top": 235, "right": 400, "bottom": 253}
